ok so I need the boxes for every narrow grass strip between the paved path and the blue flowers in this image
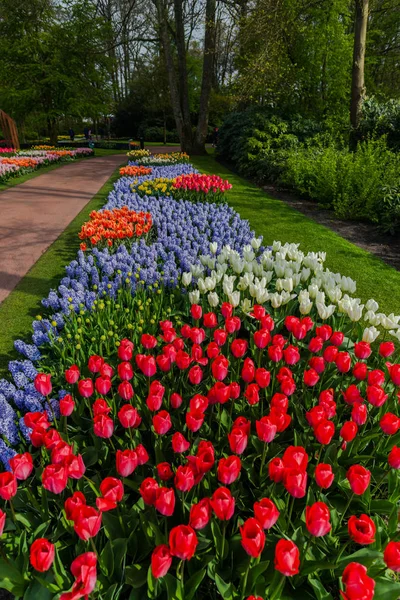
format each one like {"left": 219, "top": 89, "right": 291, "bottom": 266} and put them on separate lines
{"left": 0, "top": 164, "right": 123, "bottom": 378}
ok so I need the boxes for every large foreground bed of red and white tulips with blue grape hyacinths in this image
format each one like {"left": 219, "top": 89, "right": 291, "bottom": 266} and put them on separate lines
{"left": 0, "top": 156, "right": 400, "bottom": 600}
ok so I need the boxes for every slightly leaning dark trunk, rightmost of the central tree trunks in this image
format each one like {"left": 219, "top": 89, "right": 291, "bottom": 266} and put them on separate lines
{"left": 192, "top": 0, "right": 216, "bottom": 154}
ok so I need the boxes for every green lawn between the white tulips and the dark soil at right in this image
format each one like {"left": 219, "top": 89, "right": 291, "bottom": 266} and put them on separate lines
{"left": 191, "top": 156, "right": 400, "bottom": 314}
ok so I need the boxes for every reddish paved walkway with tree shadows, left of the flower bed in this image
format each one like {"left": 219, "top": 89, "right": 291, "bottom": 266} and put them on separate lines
{"left": 0, "top": 154, "right": 127, "bottom": 302}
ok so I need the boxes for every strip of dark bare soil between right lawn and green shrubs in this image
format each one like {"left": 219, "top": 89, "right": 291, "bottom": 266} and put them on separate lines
{"left": 263, "top": 185, "right": 400, "bottom": 271}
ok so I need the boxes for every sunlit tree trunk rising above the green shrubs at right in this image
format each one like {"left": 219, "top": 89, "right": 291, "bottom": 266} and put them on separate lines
{"left": 350, "top": 0, "right": 369, "bottom": 130}
